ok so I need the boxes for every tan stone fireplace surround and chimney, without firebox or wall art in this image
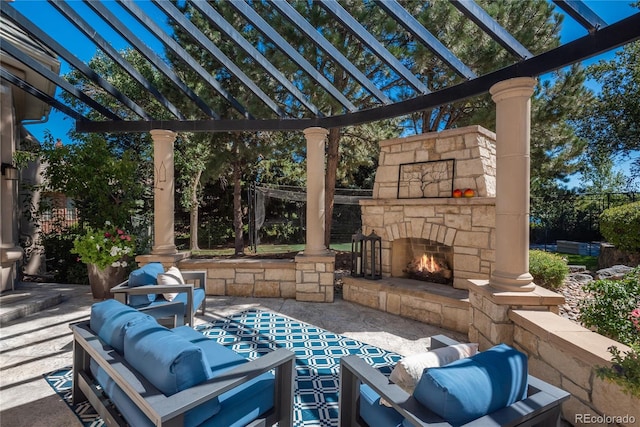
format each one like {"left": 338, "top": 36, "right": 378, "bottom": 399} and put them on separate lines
{"left": 360, "top": 126, "right": 495, "bottom": 289}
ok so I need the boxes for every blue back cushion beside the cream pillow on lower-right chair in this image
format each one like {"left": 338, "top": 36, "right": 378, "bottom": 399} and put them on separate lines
{"left": 413, "top": 344, "right": 528, "bottom": 426}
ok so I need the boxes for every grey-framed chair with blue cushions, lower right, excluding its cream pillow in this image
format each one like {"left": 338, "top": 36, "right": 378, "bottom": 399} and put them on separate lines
{"left": 340, "top": 335, "right": 571, "bottom": 427}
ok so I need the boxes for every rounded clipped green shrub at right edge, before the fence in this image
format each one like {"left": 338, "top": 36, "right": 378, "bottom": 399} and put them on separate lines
{"left": 600, "top": 202, "right": 640, "bottom": 252}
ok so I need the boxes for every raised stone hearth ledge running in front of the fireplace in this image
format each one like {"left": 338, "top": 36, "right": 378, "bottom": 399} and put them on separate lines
{"left": 342, "top": 277, "right": 469, "bottom": 333}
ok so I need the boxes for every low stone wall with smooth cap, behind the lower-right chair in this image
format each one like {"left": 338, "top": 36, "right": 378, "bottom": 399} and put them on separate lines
{"left": 509, "top": 310, "right": 640, "bottom": 426}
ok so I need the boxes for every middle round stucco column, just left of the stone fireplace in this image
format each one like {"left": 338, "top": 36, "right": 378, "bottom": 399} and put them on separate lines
{"left": 304, "top": 127, "right": 329, "bottom": 255}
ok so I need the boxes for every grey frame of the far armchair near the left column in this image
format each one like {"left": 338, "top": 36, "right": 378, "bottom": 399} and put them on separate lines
{"left": 111, "top": 271, "right": 207, "bottom": 327}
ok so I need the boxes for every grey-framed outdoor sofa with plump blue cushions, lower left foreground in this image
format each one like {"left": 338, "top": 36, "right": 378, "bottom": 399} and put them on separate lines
{"left": 71, "top": 300, "right": 295, "bottom": 427}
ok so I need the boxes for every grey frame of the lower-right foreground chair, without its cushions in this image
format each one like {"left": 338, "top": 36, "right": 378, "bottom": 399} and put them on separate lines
{"left": 339, "top": 335, "right": 571, "bottom": 427}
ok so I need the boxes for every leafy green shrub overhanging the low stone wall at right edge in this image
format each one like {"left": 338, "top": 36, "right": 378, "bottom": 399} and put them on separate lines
{"left": 580, "top": 268, "right": 640, "bottom": 345}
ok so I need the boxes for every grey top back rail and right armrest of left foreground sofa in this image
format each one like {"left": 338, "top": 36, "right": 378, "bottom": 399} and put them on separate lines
{"left": 70, "top": 321, "right": 295, "bottom": 426}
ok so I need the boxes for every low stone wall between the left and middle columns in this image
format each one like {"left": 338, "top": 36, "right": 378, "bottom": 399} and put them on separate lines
{"left": 178, "top": 258, "right": 296, "bottom": 298}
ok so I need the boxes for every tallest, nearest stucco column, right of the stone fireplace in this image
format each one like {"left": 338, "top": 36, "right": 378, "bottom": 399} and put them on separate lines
{"left": 489, "top": 77, "right": 536, "bottom": 292}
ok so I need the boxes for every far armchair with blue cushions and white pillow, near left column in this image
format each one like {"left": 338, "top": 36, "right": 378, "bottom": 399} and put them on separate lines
{"left": 111, "top": 262, "right": 207, "bottom": 327}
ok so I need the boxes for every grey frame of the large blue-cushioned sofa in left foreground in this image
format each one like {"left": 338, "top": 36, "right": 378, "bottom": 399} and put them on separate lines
{"left": 70, "top": 321, "right": 295, "bottom": 427}
